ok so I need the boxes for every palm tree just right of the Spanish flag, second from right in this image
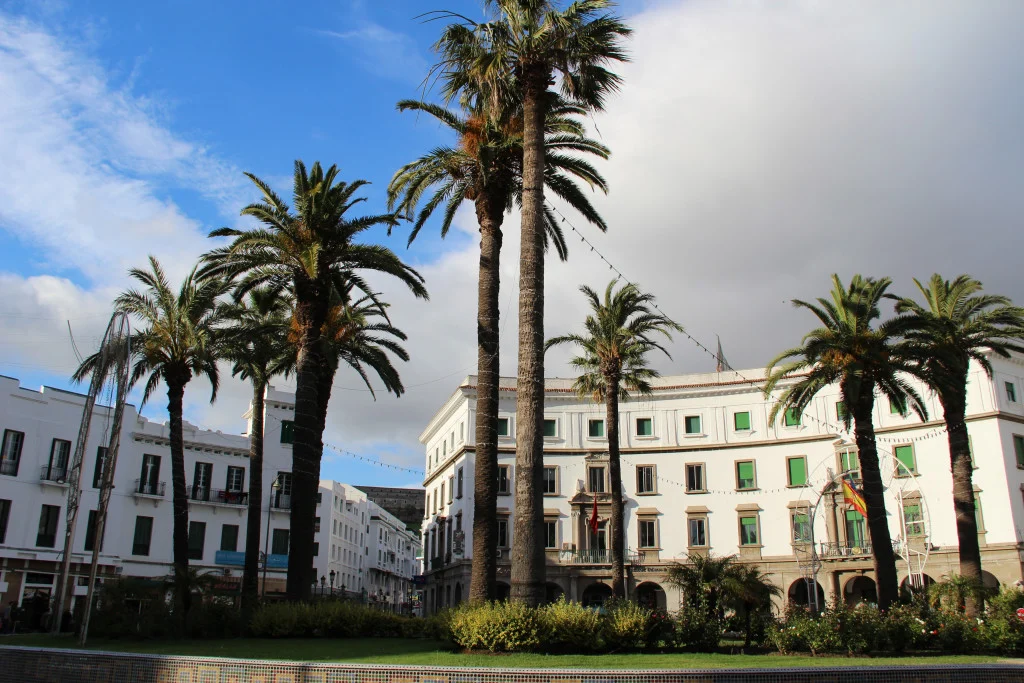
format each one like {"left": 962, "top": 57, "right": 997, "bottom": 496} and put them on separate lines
{"left": 764, "top": 275, "right": 928, "bottom": 609}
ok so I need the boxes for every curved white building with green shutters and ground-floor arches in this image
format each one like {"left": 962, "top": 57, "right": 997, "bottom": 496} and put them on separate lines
{"left": 420, "top": 358, "right": 1024, "bottom": 610}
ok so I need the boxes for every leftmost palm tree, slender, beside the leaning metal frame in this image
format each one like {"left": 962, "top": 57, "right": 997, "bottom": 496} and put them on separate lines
{"left": 74, "top": 256, "right": 227, "bottom": 615}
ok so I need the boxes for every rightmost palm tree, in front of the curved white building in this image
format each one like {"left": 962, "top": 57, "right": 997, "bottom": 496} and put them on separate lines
{"left": 896, "top": 273, "right": 1024, "bottom": 616}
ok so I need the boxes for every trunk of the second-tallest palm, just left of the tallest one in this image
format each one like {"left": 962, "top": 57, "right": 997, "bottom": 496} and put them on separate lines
{"left": 469, "top": 197, "right": 504, "bottom": 602}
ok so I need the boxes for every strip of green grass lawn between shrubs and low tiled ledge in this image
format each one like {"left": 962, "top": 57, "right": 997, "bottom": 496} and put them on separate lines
{"left": 0, "top": 634, "right": 998, "bottom": 669}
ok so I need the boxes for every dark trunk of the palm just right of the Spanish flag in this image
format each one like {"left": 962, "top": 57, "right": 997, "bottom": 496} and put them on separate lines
{"left": 853, "top": 395, "right": 899, "bottom": 609}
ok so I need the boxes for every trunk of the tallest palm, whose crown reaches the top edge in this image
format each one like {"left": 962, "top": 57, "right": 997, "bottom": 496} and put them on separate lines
{"left": 511, "top": 65, "right": 551, "bottom": 605}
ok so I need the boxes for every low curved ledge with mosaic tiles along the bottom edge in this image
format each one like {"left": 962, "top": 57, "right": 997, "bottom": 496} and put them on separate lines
{"left": 0, "top": 647, "right": 1024, "bottom": 683}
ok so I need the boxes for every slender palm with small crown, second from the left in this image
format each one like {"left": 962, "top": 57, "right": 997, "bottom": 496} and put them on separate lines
{"left": 223, "top": 287, "right": 295, "bottom": 614}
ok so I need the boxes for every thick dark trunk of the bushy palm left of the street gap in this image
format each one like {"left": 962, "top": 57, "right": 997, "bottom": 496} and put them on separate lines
{"left": 287, "top": 283, "right": 327, "bottom": 601}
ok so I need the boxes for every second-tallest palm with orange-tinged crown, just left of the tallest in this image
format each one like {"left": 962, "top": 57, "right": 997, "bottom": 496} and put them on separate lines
{"left": 388, "top": 100, "right": 608, "bottom": 602}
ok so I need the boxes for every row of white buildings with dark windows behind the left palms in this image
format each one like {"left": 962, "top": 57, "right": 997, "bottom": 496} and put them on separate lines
{"left": 0, "top": 376, "right": 413, "bottom": 618}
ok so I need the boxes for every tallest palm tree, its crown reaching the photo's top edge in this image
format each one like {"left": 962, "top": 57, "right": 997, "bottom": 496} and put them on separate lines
{"left": 436, "top": 0, "right": 630, "bottom": 604}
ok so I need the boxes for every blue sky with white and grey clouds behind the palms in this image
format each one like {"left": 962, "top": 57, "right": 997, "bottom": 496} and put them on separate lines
{"left": 0, "top": 0, "right": 1024, "bottom": 485}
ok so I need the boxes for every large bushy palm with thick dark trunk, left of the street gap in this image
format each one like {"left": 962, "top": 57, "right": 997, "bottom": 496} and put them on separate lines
{"left": 204, "top": 161, "right": 427, "bottom": 600}
